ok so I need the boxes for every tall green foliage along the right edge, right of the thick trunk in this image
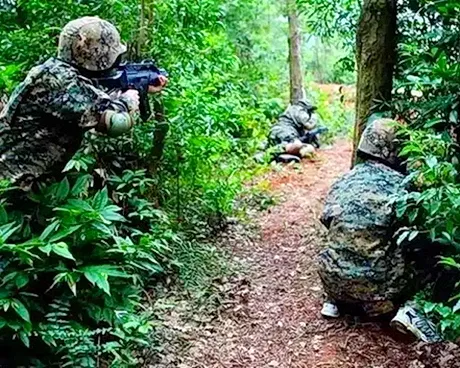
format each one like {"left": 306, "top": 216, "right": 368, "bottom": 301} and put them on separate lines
{"left": 392, "top": 1, "right": 460, "bottom": 340}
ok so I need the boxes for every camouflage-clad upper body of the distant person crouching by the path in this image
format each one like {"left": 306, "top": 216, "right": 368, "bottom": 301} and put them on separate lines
{"left": 269, "top": 105, "right": 318, "bottom": 145}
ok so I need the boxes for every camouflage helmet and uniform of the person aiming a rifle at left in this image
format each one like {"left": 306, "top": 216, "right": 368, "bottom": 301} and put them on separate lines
{"left": 0, "top": 18, "right": 132, "bottom": 188}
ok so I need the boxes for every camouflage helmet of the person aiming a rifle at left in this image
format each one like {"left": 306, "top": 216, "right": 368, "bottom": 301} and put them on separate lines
{"left": 58, "top": 17, "right": 126, "bottom": 72}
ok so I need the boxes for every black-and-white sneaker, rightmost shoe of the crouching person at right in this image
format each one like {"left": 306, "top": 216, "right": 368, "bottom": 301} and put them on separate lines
{"left": 390, "top": 305, "right": 442, "bottom": 343}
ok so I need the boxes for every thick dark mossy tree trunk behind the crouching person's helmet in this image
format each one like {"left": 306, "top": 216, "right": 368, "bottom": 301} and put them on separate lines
{"left": 353, "top": 0, "right": 397, "bottom": 164}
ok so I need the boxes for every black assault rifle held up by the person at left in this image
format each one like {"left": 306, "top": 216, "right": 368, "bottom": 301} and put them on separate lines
{"left": 93, "top": 61, "right": 168, "bottom": 121}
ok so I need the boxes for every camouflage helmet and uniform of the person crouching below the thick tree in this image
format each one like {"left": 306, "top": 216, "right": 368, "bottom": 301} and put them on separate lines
{"left": 319, "top": 119, "right": 408, "bottom": 316}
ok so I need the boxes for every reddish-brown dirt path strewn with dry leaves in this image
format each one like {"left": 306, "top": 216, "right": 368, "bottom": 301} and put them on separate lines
{"left": 150, "top": 141, "right": 460, "bottom": 368}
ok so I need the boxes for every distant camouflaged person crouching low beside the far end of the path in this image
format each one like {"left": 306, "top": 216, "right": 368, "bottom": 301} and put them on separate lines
{"left": 269, "top": 100, "right": 319, "bottom": 161}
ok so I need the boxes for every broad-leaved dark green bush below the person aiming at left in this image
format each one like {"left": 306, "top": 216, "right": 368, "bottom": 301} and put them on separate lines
{"left": 0, "top": 172, "right": 177, "bottom": 367}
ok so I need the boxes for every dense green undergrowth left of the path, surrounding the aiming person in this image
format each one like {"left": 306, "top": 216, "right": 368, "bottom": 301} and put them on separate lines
{"left": 0, "top": 0, "right": 351, "bottom": 367}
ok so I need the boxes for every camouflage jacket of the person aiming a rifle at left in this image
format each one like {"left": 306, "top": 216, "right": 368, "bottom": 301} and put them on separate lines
{"left": 0, "top": 58, "right": 128, "bottom": 187}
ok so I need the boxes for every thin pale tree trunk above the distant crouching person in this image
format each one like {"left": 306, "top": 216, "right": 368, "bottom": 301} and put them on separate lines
{"left": 287, "top": 0, "right": 305, "bottom": 104}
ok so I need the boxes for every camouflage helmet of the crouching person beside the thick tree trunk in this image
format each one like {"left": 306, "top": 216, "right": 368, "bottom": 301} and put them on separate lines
{"left": 358, "top": 118, "right": 399, "bottom": 166}
